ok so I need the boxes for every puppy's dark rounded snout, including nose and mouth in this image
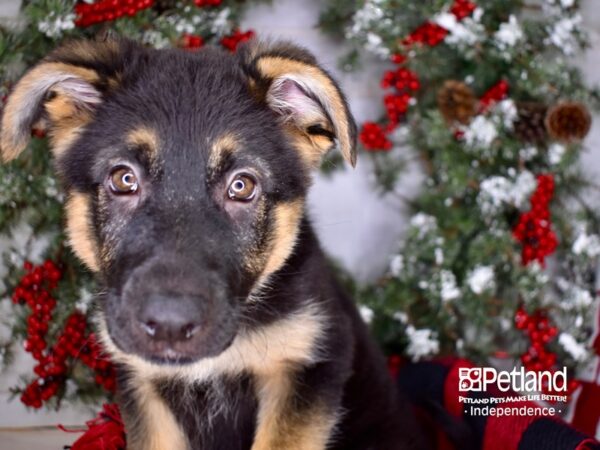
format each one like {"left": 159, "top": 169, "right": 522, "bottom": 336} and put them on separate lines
{"left": 112, "top": 256, "right": 238, "bottom": 365}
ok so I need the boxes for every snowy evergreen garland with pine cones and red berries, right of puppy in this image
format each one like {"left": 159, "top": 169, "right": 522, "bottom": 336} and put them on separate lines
{"left": 321, "top": 0, "right": 600, "bottom": 400}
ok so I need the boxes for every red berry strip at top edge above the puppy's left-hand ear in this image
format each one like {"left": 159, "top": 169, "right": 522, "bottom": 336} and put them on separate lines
{"left": 75, "top": 0, "right": 154, "bottom": 28}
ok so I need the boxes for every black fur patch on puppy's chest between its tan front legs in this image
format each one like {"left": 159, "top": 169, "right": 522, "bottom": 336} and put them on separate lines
{"left": 157, "top": 376, "right": 258, "bottom": 450}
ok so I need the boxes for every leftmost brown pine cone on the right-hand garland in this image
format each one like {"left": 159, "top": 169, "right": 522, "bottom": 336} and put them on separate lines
{"left": 437, "top": 80, "right": 477, "bottom": 124}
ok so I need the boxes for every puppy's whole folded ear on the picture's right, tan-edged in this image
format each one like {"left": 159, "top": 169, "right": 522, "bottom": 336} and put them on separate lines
{"left": 239, "top": 42, "right": 357, "bottom": 167}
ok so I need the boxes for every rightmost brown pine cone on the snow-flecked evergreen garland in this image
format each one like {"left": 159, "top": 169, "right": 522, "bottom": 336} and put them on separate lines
{"left": 546, "top": 101, "right": 592, "bottom": 141}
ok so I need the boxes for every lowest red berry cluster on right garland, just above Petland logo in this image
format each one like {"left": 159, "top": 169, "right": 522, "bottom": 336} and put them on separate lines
{"left": 515, "top": 306, "right": 579, "bottom": 394}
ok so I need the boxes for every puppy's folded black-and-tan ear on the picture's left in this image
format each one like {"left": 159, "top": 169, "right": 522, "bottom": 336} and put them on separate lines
{"left": 0, "top": 39, "right": 131, "bottom": 161}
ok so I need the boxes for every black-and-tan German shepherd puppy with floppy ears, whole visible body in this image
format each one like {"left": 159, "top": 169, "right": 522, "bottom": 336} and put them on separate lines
{"left": 0, "top": 39, "right": 420, "bottom": 450}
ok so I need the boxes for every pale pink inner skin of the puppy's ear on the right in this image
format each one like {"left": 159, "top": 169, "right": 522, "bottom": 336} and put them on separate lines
{"left": 267, "top": 77, "right": 325, "bottom": 125}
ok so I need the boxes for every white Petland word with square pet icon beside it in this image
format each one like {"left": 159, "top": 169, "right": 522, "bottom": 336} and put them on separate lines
{"left": 458, "top": 367, "right": 567, "bottom": 392}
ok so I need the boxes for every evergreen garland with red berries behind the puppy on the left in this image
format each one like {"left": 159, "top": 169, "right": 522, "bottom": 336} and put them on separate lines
{"left": 0, "top": 0, "right": 254, "bottom": 409}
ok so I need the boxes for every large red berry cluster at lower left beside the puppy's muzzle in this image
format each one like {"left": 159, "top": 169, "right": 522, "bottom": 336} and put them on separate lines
{"left": 12, "top": 260, "right": 115, "bottom": 408}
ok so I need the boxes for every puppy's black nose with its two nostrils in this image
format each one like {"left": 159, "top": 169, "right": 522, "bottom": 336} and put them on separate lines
{"left": 139, "top": 295, "right": 200, "bottom": 344}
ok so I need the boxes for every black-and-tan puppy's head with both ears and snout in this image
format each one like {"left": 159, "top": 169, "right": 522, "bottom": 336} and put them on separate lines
{"left": 0, "top": 40, "right": 356, "bottom": 363}
